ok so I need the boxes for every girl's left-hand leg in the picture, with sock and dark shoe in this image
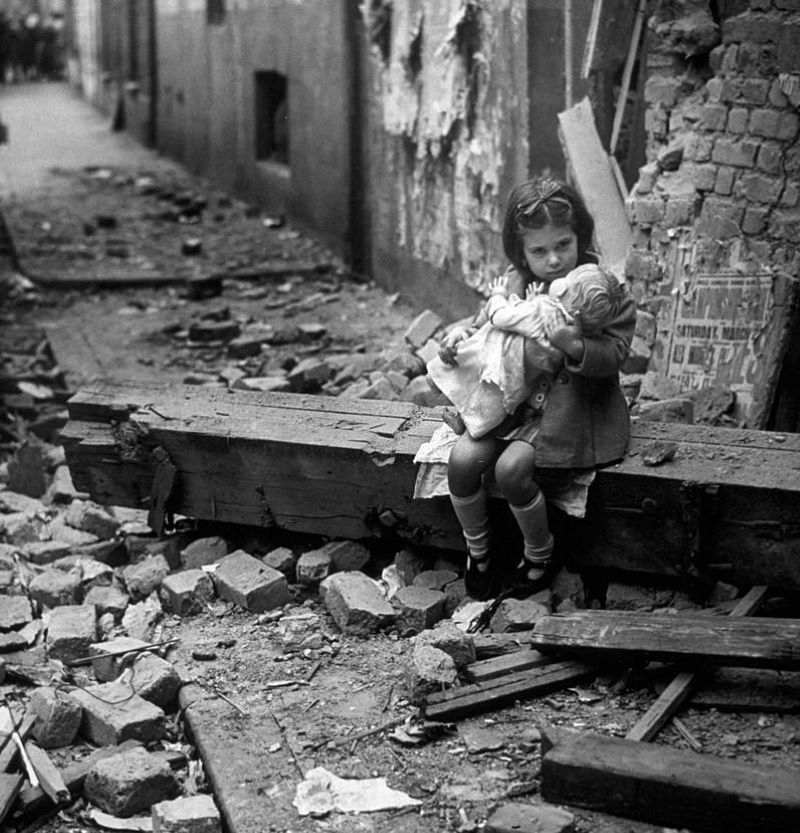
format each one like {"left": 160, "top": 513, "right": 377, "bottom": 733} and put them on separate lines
{"left": 447, "top": 434, "right": 497, "bottom": 599}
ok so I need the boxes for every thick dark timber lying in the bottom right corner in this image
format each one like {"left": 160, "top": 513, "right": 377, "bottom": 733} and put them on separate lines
{"left": 541, "top": 727, "right": 800, "bottom": 833}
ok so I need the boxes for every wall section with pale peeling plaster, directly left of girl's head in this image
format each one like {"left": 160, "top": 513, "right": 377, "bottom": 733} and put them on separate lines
{"left": 361, "top": 0, "right": 528, "bottom": 316}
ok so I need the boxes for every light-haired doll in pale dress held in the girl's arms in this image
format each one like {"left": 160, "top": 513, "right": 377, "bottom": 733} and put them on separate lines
{"left": 428, "top": 263, "right": 623, "bottom": 439}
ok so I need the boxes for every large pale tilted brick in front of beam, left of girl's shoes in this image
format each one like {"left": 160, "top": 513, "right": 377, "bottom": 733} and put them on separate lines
{"left": 320, "top": 571, "right": 397, "bottom": 636}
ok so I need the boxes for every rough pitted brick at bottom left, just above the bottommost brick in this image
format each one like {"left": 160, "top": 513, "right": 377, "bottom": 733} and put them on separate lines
{"left": 83, "top": 746, "right": 180, "bottom": 818}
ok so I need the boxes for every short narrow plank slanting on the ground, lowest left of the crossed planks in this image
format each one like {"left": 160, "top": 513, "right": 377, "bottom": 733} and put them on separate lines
{"left": 424, "top": 662, "right": 597, "bottom": 720}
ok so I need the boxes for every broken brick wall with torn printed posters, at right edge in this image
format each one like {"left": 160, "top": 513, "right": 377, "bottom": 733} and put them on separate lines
{"left": 626, "top": 0, "right": 800, "bottom": 427}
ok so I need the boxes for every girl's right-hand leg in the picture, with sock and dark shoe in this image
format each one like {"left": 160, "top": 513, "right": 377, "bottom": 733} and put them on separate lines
{"left": 495, "top": 441, "right": 554, "bottom": 582}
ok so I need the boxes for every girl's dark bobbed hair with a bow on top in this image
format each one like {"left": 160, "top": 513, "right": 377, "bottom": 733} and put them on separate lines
{"left": 503, "top": 178, "right": 596, "bottom": 278}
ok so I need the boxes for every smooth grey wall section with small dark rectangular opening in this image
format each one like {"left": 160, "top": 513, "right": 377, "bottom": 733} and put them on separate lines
{"left": 157, "top": 0, "right": 351, "bottom": 251}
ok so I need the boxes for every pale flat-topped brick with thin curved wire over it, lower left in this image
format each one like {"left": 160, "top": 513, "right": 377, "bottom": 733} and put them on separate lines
{"left": 69, "top": 680, "right": 166, "bottom": 746}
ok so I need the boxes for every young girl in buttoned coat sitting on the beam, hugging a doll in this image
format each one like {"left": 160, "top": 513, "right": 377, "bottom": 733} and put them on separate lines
{"left": 439, "top": 179, "right": 636, "bottom": 599}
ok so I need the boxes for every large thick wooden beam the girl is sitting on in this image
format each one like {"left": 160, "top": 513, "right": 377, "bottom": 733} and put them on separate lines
{"left": 62, "top": 383, "right": 800, "bottom": 589}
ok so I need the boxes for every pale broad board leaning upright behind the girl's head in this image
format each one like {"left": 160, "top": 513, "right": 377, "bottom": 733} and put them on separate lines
{"left": 558, "top": 98, "right": 631, "bottom": 266}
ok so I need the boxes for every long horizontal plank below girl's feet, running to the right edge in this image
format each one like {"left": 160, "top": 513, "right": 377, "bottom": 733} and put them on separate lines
{"left": 530, "top": 610, "right": 800, "bottom": 670}
